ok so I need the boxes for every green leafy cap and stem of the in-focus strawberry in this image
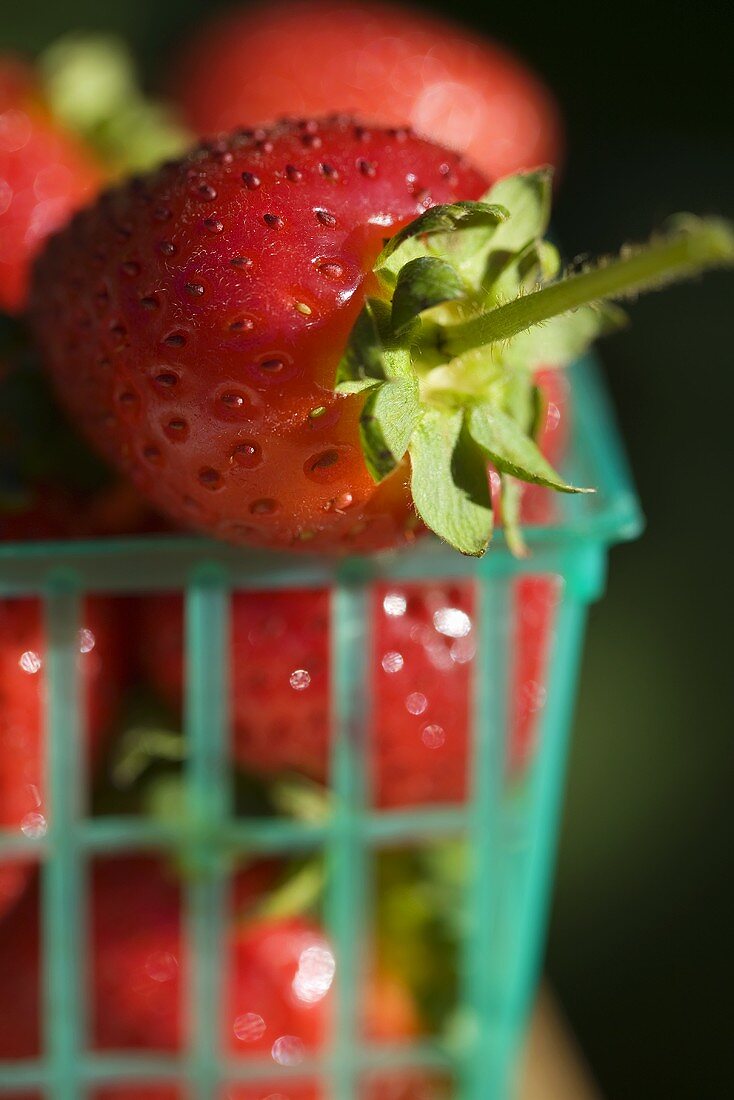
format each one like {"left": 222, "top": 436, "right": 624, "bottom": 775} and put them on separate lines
{"left": 335, "top": 169, "right": 734, "bottom": 557}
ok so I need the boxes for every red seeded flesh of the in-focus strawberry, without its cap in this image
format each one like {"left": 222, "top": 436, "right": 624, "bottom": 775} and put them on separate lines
{"left": 32, "top": 119, "right": 486, "bottom": 550}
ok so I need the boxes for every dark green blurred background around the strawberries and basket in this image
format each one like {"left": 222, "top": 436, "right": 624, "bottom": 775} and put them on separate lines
{"left": 0, "top": 0, "right": 734, "bottom": 1100}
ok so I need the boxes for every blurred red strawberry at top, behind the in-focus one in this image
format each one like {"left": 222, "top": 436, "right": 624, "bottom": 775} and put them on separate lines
{"left": 174, "top": 0, "right": 561, "bottom": 178}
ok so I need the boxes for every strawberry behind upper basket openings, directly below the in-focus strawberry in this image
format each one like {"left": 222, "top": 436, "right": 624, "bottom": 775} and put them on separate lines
{"left": 140, "top": 371, "right": 569, "bottom": 806}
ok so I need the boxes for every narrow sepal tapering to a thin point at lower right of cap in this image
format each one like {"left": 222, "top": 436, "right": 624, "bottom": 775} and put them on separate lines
{"left": 467, "top": 403, "right": 593, "bottom": 493}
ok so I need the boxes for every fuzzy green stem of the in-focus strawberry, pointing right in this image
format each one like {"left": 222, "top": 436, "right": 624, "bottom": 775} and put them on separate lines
{"left": 442, "top": 217, "right": 734, "bottom": 355}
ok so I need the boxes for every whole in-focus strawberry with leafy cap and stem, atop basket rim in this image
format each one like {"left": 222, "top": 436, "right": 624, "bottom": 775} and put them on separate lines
{"left": 32, "top": 118, "right": 734, "bottom": 556}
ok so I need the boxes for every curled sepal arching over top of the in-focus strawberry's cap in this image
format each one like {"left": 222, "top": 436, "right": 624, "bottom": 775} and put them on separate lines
{"left": 374, "top": 202, "right": 510, "bottom": 287}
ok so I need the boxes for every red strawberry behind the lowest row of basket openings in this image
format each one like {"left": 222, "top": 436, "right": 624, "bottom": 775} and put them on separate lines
{"left": 0, "top": 857, "right": 426, "bottom": 1100}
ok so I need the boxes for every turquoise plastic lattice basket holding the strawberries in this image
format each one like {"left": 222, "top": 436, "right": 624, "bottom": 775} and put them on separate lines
{"left": 0, "top": 360, "right": 642, "bottom": 1100}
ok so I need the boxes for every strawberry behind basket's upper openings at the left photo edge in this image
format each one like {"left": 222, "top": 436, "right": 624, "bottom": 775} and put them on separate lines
{"left": 0, "top": 596, "right": 124, "bottom": 916}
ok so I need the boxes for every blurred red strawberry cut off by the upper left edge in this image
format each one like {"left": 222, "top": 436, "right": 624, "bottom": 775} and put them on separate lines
{"left": 0, "top": 57, "right": 102, "bottom": 314}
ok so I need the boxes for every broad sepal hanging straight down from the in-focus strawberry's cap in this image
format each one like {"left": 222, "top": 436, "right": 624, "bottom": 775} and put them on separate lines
{"left": 409, "top": 408, "right": 493, "bottom": 558}
